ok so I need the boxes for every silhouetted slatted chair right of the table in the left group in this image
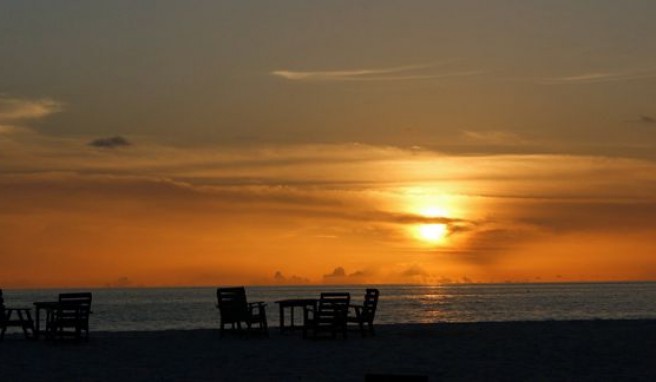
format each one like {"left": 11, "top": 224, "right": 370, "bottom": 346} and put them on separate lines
{"left": 46, "top": 292, "right": 92, "bottom": 341}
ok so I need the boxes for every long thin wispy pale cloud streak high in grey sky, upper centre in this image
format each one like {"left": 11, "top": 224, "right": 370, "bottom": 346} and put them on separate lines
{"left": 271, "top": 65, "right": 482, "bottom": 81}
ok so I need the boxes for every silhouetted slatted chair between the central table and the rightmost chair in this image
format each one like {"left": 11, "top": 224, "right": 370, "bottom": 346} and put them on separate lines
{"left": 303, "top": 292, "right": 351, "bottom": 339}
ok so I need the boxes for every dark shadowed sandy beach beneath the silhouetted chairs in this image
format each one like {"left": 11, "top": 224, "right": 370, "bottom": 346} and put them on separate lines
{"left": 0, "top": 320, "right": 656, "bottom": 382}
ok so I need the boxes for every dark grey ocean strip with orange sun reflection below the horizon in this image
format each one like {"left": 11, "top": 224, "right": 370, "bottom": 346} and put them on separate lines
{"left": 4, "top": 282, "right": 656, "bottom": 331}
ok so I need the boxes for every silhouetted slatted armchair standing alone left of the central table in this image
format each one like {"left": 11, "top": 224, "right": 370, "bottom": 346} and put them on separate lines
{"left": 216, "top": 287, "right": 269, "bottom": 337}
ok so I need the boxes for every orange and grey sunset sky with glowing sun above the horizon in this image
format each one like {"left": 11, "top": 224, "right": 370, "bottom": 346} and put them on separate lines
{"left": 0, "top": 0, "right": 656, "bottom": 288}
